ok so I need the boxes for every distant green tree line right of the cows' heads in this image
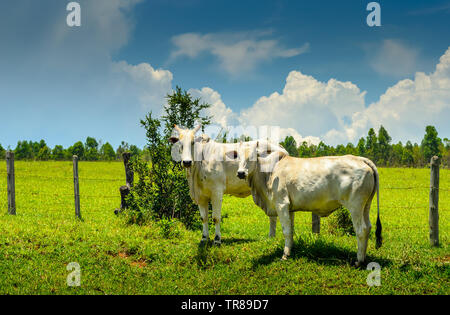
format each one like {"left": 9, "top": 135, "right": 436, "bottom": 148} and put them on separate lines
{"left": 280, "top": 126, "right": 450, "bottom": 167}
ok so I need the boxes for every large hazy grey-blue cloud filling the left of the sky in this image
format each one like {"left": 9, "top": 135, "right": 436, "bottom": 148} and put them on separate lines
{"left": 0, "top": 0, "right": 172, "bottom": 146}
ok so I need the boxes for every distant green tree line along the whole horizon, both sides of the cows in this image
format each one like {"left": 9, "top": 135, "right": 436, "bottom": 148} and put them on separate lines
{"left": 0, "top": 126, "right": 450, "bottom": 167}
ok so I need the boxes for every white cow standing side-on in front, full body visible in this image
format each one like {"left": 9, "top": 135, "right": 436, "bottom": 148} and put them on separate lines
{"left": 237, "top": 143, "right": 381, "bottom": 266}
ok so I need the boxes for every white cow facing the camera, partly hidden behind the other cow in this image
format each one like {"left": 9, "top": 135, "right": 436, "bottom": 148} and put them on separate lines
{"left": 170, "top": 125, "right": 288, "bottom": 245}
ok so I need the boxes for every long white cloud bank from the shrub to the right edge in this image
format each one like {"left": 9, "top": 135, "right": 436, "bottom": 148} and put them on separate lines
{"left": 191, "top": 47, "right": 450, "bottom": 145}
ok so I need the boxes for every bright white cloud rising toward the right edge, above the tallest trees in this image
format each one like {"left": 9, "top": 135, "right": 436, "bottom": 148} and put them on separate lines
{"left": 338, "top": 47, "right": 450, "bottom": 142}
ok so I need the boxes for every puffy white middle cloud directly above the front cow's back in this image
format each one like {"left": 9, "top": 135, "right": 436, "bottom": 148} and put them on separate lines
{"left": 241, "top": 71, "right": 365, "bottom": 143}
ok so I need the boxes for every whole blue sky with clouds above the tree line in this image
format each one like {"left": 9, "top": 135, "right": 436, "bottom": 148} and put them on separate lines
{"left": 0, "top": 0, "right": 450, "bottom": 148}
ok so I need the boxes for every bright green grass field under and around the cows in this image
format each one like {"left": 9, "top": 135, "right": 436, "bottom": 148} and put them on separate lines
{"left": 0, "top": 162, "right": 450, "bottom": 294}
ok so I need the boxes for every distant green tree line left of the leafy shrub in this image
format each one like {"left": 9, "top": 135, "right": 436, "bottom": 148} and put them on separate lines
{"left": 0, "top": 137, "right": 148, "bottom": 161}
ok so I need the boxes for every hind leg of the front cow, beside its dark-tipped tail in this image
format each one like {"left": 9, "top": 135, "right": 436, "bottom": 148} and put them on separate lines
{"left": 349, "top": 200, "right": 372, "bottom": 267}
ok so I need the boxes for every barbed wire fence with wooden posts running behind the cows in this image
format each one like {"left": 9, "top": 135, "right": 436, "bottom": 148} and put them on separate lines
{"left": 0, "top": 151, "right": 450, "bottom": 246}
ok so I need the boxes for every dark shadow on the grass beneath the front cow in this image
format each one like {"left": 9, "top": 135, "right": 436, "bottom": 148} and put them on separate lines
{"left": 253, "top": 238, "right": 392, "bottom": 269}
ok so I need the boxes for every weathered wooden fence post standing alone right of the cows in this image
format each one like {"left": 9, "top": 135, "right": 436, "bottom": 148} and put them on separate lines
{"left": 429, "top": 156, "right": 440, "bottom": 246}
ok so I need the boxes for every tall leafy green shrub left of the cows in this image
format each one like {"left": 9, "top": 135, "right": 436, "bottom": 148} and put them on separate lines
{"left": 127, "top": 87, "right": 210, "bottom": 228}
